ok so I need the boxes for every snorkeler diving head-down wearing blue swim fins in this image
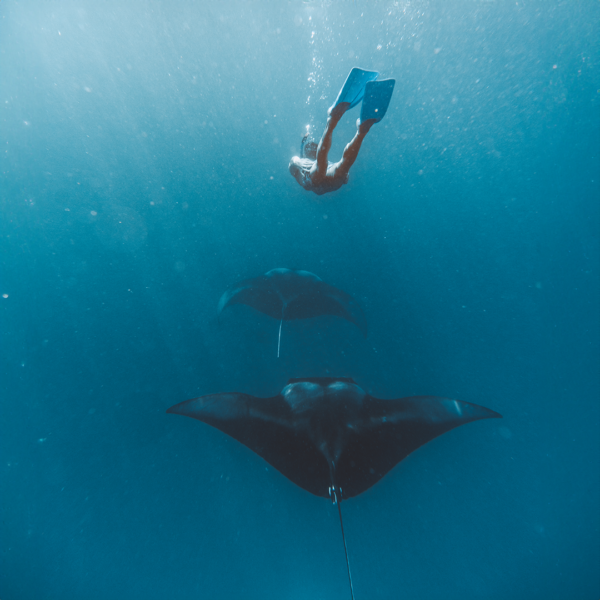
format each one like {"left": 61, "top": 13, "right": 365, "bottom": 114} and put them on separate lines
{"left": 289, "top": 67, "right": 396, "bottom": 196}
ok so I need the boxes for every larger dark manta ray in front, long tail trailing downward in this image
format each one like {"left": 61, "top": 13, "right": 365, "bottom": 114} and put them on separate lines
{"left": 167, "top": 377, "right": 502, "bottom": 598}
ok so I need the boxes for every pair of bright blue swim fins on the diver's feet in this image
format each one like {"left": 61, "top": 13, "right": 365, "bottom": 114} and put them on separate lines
{"left": 331, "top": 67, "right": 396, "bottom": 123}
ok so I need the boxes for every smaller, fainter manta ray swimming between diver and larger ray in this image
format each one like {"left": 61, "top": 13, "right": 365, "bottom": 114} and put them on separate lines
{"left": 217, "top": 269, "right": 367, "bottom": 357}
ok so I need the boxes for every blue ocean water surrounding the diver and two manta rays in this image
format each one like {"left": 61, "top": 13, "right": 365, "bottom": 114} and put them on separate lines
{"left": 0, "top": 0, "right": 600, "bottom": 600}
